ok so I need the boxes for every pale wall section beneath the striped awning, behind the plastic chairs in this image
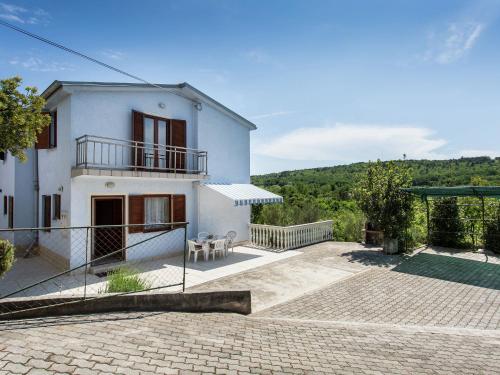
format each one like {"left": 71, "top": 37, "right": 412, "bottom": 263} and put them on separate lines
{"left": 199, "top": 185, "right": 250, "bottom": 242}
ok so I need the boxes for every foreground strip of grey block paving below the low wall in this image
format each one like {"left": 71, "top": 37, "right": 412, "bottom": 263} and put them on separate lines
{"left": 0, "top": 313, "right": 500, "bottom": 374}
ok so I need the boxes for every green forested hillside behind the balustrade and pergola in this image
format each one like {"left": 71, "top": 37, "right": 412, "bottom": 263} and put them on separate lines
{"left": 252, "top": 157, "right": 500, "bottom": 241}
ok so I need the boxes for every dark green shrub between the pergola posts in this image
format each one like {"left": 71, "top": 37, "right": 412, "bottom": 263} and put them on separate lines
{"left": 431, "top": 197, "right": 465, "bottom": 248}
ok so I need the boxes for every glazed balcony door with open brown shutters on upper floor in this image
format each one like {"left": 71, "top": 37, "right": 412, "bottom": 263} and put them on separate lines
{"left": 132, "top": 111, "right": 187, "bottom": 173}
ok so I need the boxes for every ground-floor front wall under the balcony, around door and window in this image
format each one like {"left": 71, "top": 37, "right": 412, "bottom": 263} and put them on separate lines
{"left": 71, "top": 176, "right": 197, "bottom": 267}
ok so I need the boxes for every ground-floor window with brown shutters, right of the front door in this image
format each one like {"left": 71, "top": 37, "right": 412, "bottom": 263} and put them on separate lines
{"left": 128, "top": 194, "right": 186, "bottom": 233}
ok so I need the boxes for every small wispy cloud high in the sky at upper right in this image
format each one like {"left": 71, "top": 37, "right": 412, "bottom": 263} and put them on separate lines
{"left": 422, "top": 21, "right": 485, "bottom": 65}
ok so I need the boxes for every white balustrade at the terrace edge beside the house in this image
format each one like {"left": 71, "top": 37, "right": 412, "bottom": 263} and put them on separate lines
{"left": 249, "top": 220, "right": 333, "bottom": 251}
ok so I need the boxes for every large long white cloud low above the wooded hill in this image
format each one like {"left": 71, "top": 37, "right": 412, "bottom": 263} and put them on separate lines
{"left": 254, "top": 124, "right": 447, "bottom": 163}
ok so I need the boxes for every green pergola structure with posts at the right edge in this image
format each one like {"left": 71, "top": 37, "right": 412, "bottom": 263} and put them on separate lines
{"left": 402, "top": 186, "right": 500, "bottom": 250}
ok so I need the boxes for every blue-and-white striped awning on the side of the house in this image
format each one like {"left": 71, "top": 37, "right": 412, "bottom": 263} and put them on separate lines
{"left": 203, "top": 184, "right": 283, "bottom": 206}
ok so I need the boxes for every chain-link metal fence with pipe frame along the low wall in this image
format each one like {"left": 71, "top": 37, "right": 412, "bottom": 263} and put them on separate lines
{"left": 0, "top": 223, "right": 188, "bottom": 318}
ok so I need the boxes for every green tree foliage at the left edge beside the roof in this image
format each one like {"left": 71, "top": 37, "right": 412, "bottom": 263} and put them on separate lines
{"left": 0, "top": 77, "right": 50, "bottom": 161}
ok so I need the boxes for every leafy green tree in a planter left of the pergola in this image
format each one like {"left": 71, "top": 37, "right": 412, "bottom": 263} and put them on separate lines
{"left": 356, "top": 160, "right": 413, "bottom": 251}
